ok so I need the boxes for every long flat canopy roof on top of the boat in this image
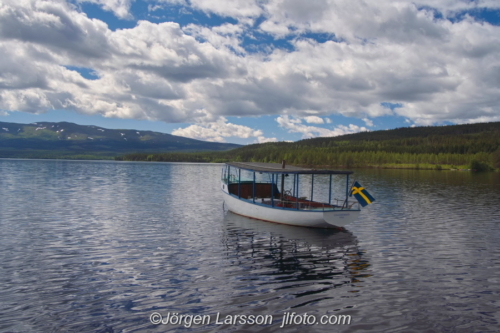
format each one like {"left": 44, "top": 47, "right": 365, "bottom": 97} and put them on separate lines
{"left": 226, "top": 162, "right": 353, "bottom": 175}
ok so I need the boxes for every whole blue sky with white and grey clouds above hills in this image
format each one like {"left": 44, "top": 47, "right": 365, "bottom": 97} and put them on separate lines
{"left": 0, "top": 0, "right": 500, "bottom": 144}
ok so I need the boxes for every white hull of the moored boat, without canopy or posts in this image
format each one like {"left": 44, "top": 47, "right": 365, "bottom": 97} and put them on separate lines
{"left": 223, "top": 191, "right": 360, "bottom": 228}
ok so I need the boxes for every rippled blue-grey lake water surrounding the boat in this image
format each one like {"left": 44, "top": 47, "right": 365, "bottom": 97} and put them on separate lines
{"left": 0, "top": 159, "right": 500, "bottom": 333}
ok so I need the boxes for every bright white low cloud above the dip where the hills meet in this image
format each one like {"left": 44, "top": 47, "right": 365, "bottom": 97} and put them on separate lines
{"left": 172, "top": 117, "right": 277, "bottom": 143}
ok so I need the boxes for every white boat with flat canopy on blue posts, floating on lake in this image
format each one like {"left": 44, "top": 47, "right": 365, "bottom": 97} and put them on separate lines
{"left": 221, "top": 161, "right": 374, "bottom": 229}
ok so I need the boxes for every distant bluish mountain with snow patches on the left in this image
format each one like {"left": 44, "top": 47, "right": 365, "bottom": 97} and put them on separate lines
{"left": 0, "top": 122, "right": 241, "bottom": 159}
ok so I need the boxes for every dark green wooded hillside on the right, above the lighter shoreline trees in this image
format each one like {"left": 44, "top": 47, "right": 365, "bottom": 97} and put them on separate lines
{"left": 226, "top": 122, "right": 500, "bottom": 154}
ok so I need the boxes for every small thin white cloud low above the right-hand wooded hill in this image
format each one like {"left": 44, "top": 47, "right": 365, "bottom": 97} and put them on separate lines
{"left": 276, "top": 115, "right": 368, "bottom": 139}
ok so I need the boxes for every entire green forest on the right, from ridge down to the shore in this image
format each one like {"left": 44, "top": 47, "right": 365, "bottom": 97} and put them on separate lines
{"left": 116, "top": 122, "right": 500, "bottom": 170}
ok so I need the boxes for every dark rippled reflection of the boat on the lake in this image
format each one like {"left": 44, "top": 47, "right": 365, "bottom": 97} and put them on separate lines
{"left": 223, "top": 212, "right": 370, "bottom": 308}
